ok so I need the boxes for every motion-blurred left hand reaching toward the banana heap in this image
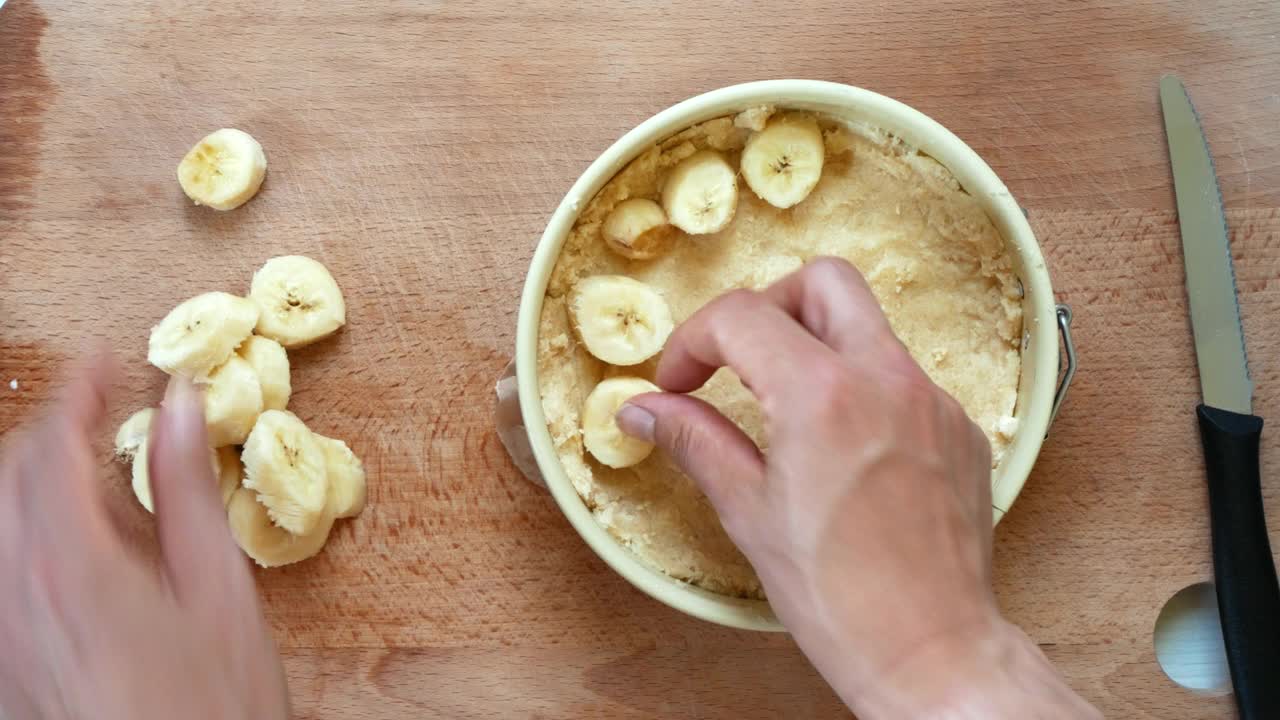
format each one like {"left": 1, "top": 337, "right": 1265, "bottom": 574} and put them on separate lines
{"left": 0, "top": 360, "right": 289, "bottom": 720}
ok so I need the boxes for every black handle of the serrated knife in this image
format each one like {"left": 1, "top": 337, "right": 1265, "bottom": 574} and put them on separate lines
{"left": 1196, "top": 405, "right": 1280, "bottom": 720}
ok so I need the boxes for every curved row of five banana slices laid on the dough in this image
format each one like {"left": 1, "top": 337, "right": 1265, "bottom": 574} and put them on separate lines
{"left": 568, "top": 114, "right": 826, "bottom": 468}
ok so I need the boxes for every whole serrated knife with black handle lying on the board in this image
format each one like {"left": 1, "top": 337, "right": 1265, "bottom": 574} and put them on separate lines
{"left": 1160, "top": 76, "right": 1280, "bottom": 720}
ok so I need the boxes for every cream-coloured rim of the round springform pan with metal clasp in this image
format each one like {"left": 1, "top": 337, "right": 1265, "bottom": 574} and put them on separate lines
{"left": 516, "top": 79, "right": 1074, "bottom": 630}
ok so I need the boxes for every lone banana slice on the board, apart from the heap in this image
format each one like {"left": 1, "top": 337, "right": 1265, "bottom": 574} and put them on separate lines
{"left": 178, "top": 128, "right": 266, "bottom": 210}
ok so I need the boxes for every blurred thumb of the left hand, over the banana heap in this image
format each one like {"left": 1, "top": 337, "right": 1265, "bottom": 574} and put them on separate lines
{"left": 147, "top": 378, "right": 252, "bottom": 602}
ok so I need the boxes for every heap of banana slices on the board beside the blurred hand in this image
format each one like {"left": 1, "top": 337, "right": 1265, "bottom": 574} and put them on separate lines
{"left": 115, "top": 255, "right": 365, "bottom": 568}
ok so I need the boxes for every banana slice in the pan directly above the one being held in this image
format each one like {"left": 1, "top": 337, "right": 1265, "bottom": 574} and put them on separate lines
{"left": 570, "top": 275, "right": 676, "bottom": 365}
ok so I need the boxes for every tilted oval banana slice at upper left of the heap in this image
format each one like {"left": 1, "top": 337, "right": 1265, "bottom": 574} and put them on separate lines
{"left": 147, "top": 292, "right": 259, "bottom": 380}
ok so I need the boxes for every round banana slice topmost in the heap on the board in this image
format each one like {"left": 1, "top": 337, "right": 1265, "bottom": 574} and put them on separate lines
{"left": 248, "top": 255, "right": 347, "bottom": 347}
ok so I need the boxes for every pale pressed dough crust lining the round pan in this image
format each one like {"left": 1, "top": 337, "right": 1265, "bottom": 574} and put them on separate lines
{"left": 538, "top": 109, "right": 1023, "bottom": 598}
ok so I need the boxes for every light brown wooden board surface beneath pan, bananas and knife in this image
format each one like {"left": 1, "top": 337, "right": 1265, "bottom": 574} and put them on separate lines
{"left": 0, "top": 0, "right": 1280, "bottom": 719}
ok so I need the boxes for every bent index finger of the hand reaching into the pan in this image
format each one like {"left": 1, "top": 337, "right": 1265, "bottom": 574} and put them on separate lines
{"left": 657, "top": 290, "right": 833, "bottom": 402}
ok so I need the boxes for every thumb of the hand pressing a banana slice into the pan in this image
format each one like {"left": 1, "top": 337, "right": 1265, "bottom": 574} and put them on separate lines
{"left": 617, "top": 392, "right": 764, "bottom": 525}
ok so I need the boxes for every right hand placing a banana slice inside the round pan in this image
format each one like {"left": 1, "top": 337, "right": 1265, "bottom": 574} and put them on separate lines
{"left": 618, "top": 259, "right": 1097, "bottom": 720}
